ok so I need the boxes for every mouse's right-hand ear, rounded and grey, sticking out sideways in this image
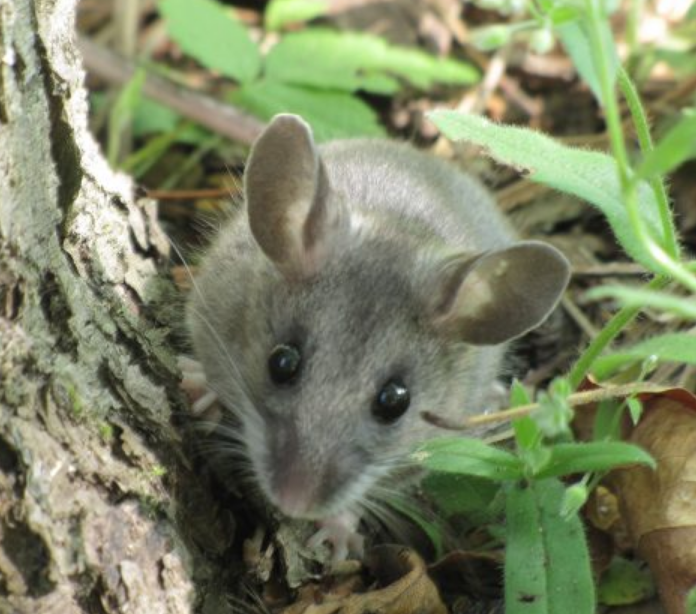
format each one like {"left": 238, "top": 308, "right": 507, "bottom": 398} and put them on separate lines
{"left": 431, "top": 241, "right": 570, "bottom": 345}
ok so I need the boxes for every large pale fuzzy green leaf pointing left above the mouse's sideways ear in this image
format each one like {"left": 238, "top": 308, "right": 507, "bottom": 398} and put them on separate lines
{"left": 428, "top": 110, "right": 662, "bottom": 268}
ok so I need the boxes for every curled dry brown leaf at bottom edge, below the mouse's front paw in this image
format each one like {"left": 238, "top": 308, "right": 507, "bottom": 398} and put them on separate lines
{"left": 283, "top": 546, "right": 447, "bottom": 614}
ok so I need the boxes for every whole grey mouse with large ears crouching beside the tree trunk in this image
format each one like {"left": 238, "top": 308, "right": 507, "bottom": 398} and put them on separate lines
{"left": 184, "top": 114, "right": 570, "bottom": 560}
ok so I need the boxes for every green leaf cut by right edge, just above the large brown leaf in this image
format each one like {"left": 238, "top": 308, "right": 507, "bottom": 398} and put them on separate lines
{"left": 593, "top": 333, "right": 696, "bottom": 379}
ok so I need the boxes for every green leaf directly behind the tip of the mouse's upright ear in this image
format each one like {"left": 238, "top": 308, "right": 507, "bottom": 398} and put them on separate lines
{"left": 230, "top": 80, "right": 386, "bottom": 141}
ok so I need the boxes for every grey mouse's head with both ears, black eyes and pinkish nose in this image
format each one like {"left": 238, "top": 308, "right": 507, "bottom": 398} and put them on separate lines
{"left": 237, "top": 115, "right": 569, "bottom": 518}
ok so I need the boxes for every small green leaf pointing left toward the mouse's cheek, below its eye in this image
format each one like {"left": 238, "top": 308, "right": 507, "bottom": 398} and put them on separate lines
{"left": 412, "top": 437, "right": 523, "bottom": 481}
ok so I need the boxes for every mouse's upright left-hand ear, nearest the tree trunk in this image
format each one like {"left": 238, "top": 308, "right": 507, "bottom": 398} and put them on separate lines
{"left": 244, "top": 114, "right": 346, "bottom": 278}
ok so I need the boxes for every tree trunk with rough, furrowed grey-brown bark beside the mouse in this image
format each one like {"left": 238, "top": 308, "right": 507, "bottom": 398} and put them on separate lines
{"left": 0, "top": 0, "right": 239, "bottom": 614}
